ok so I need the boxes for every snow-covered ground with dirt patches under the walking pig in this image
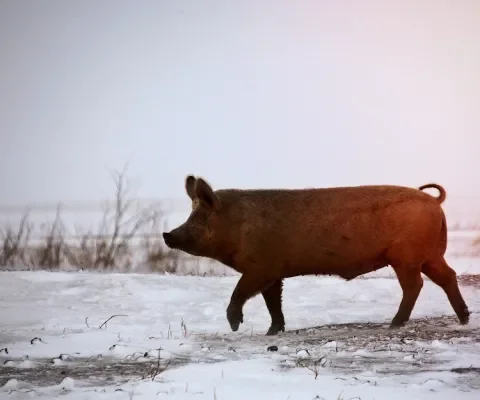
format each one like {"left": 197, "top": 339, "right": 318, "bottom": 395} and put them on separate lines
{"left": 0, "top": 260, "right": 480, "bottom": 400}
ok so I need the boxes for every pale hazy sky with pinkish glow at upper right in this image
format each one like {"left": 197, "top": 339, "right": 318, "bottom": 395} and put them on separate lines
{"left": 0, "top": 0, "right": 480, "bottom": 222}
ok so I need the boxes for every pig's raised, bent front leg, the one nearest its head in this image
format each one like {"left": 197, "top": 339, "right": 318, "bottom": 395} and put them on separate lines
{"left": 227, "top": 273, "right": 275, "bottom": 332}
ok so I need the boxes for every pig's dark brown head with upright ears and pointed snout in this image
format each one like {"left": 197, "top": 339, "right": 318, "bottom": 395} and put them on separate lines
{"left": 163, "top": 175, "right": 228, "bottom": 257}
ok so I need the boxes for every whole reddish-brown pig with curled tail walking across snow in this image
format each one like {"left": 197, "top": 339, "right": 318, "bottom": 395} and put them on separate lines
{"left": 163, "top": 175, "right": 470, "bottom": 335}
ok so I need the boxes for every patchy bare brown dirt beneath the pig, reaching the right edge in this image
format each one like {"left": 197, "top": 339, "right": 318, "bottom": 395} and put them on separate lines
{"left": 198, "top": 316, "right": 480, "bottom": 390}
